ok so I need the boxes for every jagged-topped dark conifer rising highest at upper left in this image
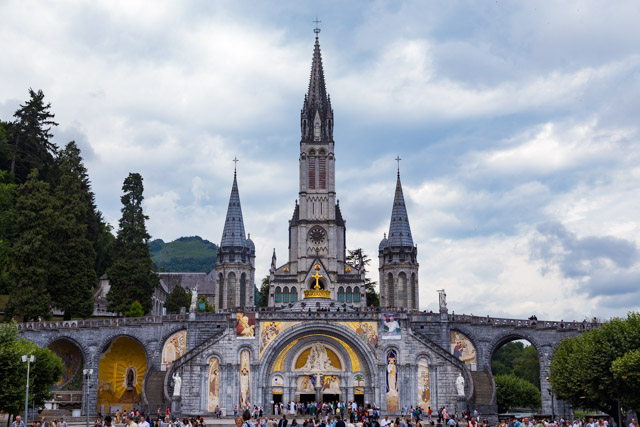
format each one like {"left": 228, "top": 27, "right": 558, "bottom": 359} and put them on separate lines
{"left": 9, "top": 88, "right": 58, "bottom": 183}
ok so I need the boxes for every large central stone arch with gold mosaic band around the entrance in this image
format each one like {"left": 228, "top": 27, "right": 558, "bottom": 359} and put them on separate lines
{"left": 256, "top": 321, "right": 379, "bottom": 408}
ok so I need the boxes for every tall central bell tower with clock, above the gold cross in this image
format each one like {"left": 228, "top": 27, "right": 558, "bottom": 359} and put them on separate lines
{"left": 269, "top": 27, "right": 366, "bottom": 306}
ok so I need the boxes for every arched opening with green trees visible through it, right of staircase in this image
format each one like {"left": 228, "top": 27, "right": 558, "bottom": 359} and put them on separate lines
{"left": 491, "top": 337, "right": 540, "bottom": 415}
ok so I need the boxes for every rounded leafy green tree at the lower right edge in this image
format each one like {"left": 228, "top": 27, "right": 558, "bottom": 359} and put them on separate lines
{"left": 550, "top": 313, "right": 640, "bottom": 414}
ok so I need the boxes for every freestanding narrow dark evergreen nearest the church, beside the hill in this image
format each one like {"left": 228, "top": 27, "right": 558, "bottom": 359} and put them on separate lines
{"left": 107, "top": 173, "right": 159, "bottom": 313}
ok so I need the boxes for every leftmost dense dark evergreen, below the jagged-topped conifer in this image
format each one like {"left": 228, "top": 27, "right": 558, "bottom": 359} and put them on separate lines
{"left": 6, "top": 169, "right": 58, "bottom": 321}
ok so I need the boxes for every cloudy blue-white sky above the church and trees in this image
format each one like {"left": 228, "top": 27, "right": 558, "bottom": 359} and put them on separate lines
{"left": 0, "top": 0, "right": 640, "bottom": 320}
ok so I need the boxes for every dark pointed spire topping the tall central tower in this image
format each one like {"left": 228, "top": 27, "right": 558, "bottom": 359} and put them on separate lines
{"left": 300, "top": 28, "right": 333, "bottom": 142}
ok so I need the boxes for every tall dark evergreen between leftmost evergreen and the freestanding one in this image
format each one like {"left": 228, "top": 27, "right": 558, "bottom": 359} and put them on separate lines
{"left": 48, "top": 141, "right": 98, "bottom": 320}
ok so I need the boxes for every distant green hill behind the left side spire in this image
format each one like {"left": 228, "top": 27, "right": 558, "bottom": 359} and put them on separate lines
{"left": 149, "top": 236, "right": 218, "bottom": 273}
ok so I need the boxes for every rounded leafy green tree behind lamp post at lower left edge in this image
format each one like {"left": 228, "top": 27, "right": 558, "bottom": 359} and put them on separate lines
{"left": 0, "top": 323, "right": 64, "bottom": 415}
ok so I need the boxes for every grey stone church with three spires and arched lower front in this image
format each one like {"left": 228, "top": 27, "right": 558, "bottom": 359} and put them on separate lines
{"left": 19, "top": 33, "right": 588, "bottom": 417}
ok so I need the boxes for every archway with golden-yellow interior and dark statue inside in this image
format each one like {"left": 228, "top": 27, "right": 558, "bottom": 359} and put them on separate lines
{"left": 96, "top": 336, "right": 147, "bottom": 414}
